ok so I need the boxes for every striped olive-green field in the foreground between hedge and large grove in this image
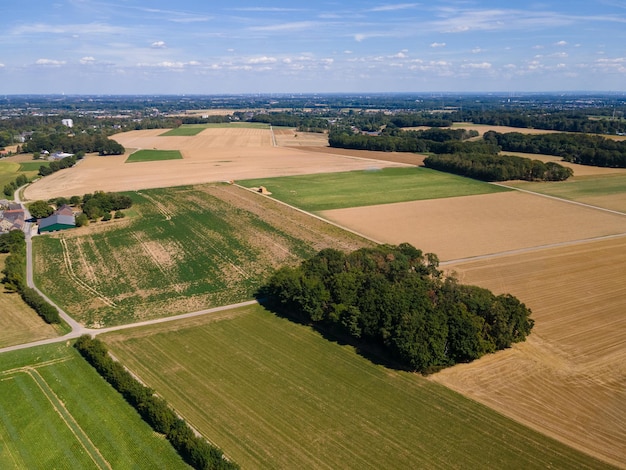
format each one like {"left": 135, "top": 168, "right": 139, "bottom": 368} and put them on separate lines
{"left": 101, "top": 306, "right": 604, "bottom": 469}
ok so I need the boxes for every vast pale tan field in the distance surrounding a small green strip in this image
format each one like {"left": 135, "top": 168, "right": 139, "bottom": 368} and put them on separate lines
{"left": 24, "top": 128, "right": 401, "bottom": 200}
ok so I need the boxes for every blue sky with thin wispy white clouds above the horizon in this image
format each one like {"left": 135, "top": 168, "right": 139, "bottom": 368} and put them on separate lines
{"left": 0, "top": 0, "right": 626, "bottom": 94}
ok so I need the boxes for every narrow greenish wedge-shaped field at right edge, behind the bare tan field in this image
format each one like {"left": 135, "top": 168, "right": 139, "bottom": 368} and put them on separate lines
{"left": 506, "top": 174, "right": 626, "bottom": 212}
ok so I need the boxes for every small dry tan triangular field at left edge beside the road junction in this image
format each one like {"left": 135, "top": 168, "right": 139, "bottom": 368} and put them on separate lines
{"left": 0, "top": 254, "right": 60, "bottom": 348}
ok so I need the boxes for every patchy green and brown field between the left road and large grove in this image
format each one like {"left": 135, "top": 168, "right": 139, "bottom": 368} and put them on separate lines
{"left": 33, "top": 184, "right": 371, "bottom": 328}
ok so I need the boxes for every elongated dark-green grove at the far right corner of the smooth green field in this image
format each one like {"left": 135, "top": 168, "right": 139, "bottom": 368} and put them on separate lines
{"left": 424, "top": 153, "right": 574, "bottom": 181}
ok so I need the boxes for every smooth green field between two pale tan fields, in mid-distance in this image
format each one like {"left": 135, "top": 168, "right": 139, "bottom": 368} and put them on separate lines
{"left": 237, "top": 167, "right": 506, "bottom": 212}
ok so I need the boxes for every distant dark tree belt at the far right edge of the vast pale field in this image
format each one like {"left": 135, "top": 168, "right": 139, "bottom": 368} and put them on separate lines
{"left": 328, "top": 126, "right": 478, "bottom": 153}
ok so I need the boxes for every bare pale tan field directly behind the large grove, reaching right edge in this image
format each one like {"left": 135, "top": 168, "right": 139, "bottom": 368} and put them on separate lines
{"left": 321, "top": 191, "right": 626, "bottom": 261}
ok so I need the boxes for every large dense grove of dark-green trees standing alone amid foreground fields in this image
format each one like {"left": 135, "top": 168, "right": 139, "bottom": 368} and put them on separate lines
{"left": 259, "top": 243, "right": 533, "bottom": 373}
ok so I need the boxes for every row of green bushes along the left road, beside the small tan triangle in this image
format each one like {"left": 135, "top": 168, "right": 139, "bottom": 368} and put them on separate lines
{"left": 0, "top": 230, "right": 61, "bottom": 323}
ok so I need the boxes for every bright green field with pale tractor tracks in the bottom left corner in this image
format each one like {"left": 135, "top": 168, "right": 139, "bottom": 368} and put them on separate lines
{"left": 0, "top": 344, "right": 188, "bottom": 469}
